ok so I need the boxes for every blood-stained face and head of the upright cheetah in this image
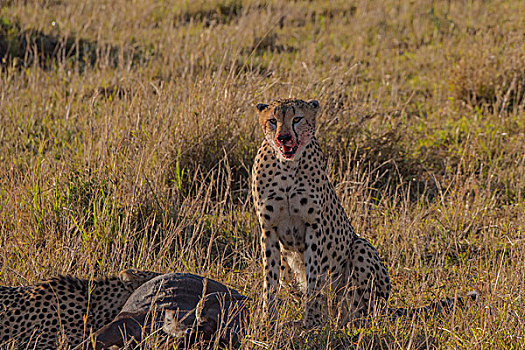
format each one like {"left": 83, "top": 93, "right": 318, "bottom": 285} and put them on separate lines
{"left": 257, "top": 99, "right": 319, "bottom": 161}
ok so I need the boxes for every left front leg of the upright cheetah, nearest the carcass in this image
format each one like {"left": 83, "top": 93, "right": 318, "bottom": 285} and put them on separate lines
{"left": 261, "top": 228, "right": 281, "bottom": 321}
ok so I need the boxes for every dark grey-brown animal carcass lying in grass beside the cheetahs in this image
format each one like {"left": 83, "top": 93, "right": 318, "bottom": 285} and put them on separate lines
{"left": 76, "top": 273, "right": 248, "bottom": 350}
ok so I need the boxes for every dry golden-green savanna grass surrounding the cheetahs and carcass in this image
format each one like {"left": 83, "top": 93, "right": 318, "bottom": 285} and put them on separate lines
{"left": 0, "top": 0, "right": 525, "bottom": 349}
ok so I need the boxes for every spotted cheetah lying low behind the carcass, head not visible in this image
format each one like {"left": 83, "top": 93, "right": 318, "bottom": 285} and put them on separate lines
{"left": 0, "top": 270, "right": 159, "bottom": 349}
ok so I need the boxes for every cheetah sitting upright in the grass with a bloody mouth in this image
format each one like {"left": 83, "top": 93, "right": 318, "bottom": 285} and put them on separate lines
{"left": 252, "top": 99, "right": 390, "bottom": 327}
